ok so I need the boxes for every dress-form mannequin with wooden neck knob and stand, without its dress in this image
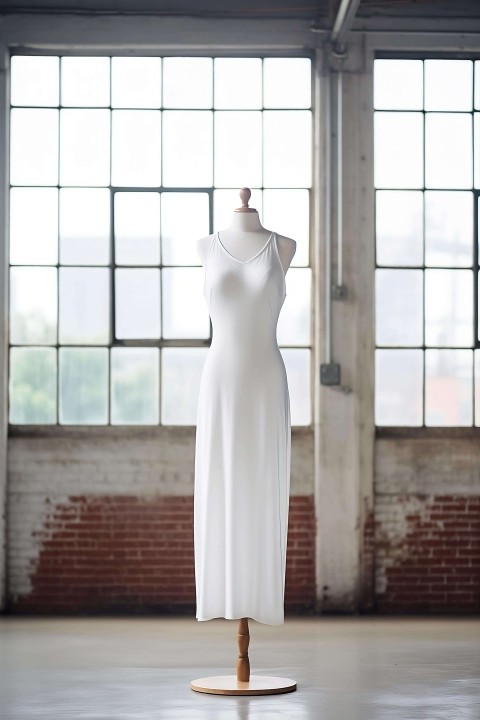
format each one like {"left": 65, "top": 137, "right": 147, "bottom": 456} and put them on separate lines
{"left": 191, "top": 188, "right": 297, "bottom": 695}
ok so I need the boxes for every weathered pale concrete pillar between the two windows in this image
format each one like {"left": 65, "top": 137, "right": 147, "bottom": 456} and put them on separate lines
{"left": 315, "top": 36, "right": 375, "bottom": 612}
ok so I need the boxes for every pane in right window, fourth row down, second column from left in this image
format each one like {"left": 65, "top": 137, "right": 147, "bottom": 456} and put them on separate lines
{"left": 425, "top": 270, "right": 473, "bottom": 347}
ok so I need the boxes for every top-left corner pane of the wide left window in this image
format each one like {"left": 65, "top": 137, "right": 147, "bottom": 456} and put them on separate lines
{"left": 10, "top": 55, "right": 58, "bottom": 107}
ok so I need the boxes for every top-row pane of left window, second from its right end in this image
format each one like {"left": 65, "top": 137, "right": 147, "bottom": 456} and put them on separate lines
{"left": 214, "top": 58, "right": 262, "bottom": 110}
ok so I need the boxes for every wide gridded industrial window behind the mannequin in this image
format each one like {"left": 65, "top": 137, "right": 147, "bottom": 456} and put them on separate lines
{"left": 9, "top": 55, "right": 312, "bottom": 425}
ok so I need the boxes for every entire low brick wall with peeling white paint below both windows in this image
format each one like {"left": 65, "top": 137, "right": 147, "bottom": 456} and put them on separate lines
{"left": 7, "top": 428, "right": 480, "bottom": 613}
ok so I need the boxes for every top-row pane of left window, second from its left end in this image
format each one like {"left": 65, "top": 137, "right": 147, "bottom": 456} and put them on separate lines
{"left": 61, "top": 57, "right": 110, "bottom": 107}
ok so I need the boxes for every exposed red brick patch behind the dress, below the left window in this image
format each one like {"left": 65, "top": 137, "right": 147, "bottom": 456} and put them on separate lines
{"left": 7, "top": 495, "right": 315, "bottom": 613}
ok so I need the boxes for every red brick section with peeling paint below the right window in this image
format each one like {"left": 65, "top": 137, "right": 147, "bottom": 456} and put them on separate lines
{"left": 375, "top": 494, "right": 480, "bottom": 613}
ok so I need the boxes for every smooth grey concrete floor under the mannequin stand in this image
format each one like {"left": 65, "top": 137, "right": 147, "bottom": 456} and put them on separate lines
{"left": 0, "top": 616, "right": 480, "bottom": 720}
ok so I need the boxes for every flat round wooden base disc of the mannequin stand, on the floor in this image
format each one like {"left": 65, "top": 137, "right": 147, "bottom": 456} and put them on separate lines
{"left": 190, "top": 675, "right": 297, "bottom": 695}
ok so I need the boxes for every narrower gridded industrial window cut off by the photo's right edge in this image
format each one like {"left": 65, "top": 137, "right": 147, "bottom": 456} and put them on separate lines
{"left": 374, "top": 58, "right": 480, "bottom": 426}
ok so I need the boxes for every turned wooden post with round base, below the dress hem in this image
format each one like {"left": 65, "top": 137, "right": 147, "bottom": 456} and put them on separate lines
{"left": 190, "top": 618, "right": 297, "bottom": 695}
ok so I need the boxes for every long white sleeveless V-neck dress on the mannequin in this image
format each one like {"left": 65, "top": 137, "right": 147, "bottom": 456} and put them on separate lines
{"left": 194, "top": 232, "right": 291, "bottom": 625}
